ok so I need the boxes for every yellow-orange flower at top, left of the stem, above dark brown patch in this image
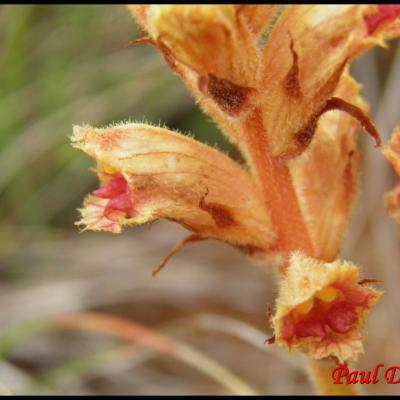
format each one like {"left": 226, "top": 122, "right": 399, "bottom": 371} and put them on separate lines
{"left": 128, "top": 4, "right": 259, "bottom": 86}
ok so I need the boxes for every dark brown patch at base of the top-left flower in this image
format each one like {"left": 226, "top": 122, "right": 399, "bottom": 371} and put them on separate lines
{"left": 199, "top": 74, "right": 254, "bottom": 115}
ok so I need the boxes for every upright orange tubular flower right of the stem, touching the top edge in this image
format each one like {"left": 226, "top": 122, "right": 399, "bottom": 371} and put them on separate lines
{"left": 260, "top": 5, "right": 395, "bottom": 158}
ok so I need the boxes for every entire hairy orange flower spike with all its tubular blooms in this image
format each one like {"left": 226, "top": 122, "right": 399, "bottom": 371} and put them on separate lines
{"left": 72, "top": 5, "right": 400, "bottom": 376}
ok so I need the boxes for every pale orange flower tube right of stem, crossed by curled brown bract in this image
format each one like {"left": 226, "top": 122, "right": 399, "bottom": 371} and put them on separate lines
{"left": 288, "top": 74, "right": 366, "bottom": 261}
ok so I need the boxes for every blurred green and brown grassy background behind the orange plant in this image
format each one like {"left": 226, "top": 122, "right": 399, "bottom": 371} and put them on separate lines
{"left": 0, "top": 5, "right": 400, "bottom": 394}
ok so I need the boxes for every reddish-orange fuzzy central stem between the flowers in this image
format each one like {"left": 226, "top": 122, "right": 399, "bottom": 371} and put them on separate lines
{"left": 243, "top": 108, "right": 360, "bottom": 395}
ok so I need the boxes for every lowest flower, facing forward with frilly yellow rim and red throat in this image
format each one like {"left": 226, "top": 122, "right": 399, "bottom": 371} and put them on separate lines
{"left": 272, "top": 253, "right": 381, "bottom": 362}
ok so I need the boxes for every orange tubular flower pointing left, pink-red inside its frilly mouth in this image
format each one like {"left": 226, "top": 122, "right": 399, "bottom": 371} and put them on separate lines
{"left": 72, "top": 123, "right": 274, "bottom": 260}
